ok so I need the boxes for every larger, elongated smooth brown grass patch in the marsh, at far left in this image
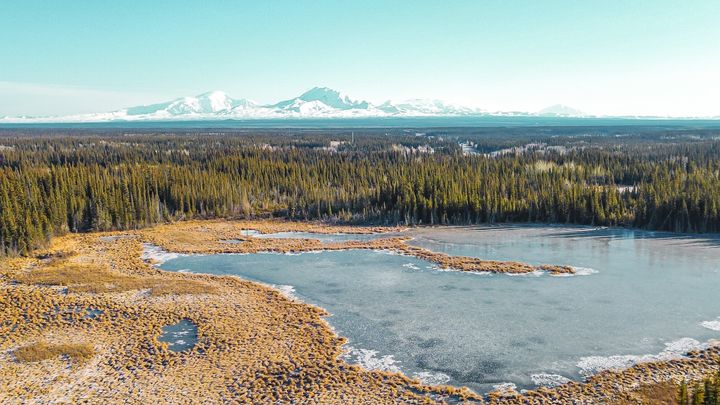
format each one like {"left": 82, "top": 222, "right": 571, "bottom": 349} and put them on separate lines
{"left": 17, "top": 263, "right": 212, "bottom": 296}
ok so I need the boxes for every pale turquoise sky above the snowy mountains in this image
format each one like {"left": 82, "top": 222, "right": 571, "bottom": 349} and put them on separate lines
{"left": 0, "top": 0, "right": 720, "bottom": 116}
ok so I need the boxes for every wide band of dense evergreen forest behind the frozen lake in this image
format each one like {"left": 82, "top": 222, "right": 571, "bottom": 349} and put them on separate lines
{"left": 0, "top": 130, "right": 720, "bottom": 254}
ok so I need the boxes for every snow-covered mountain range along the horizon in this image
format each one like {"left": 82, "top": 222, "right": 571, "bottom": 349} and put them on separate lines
{"left": 0, "top": 87, "right": 586, "bottom": 123}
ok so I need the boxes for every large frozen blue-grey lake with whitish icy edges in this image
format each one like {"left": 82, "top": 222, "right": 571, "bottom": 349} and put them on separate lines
{"left": 162, "top": 226, "right": 720, "bottom": 392}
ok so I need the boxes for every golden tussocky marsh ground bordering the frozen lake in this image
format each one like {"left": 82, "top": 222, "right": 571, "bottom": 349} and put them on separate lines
{"left": 0, "top": 221, "right": 720, "bottom": 404}
